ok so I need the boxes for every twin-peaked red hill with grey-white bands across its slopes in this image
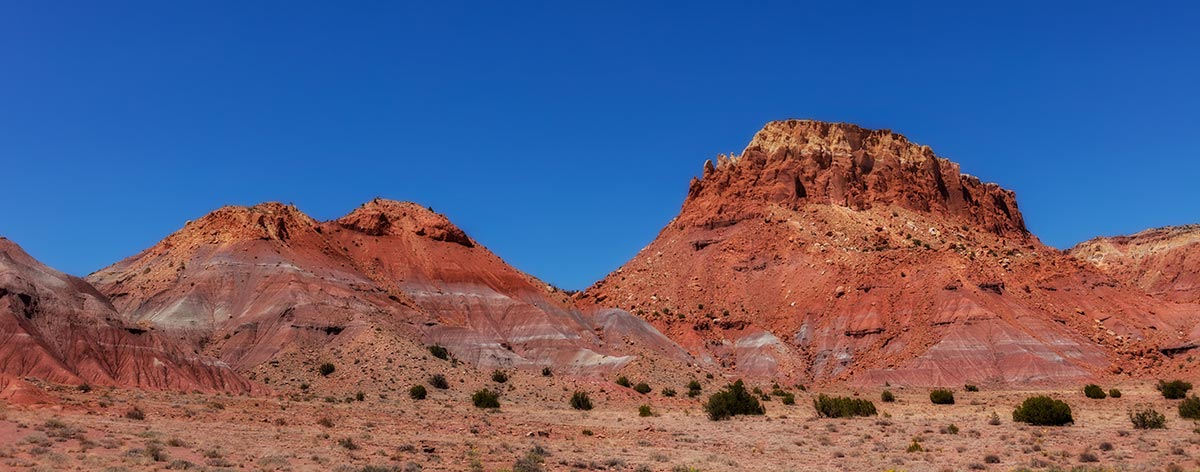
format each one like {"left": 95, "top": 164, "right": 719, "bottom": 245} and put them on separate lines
{"left": 89, "top": 199, "right": 688, "bottom": 388}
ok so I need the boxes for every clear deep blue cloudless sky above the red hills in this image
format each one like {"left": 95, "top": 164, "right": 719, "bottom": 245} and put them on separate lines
{"left": 0, "top": 0, "right": 1200, "bottom": 288}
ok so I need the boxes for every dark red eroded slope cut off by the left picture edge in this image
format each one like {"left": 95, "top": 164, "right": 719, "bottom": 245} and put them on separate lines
{"left": 0, "top": 238, "right": 254, "bottom": 396}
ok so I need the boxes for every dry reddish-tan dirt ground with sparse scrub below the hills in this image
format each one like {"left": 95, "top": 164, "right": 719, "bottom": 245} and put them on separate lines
{"left": 0, "top": 378, "right": 1200, "bottom": 471}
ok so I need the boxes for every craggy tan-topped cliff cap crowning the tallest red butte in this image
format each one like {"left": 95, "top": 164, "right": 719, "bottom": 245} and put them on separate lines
{"left": 677, "top": 120, "right": 1027, "bottom": 238}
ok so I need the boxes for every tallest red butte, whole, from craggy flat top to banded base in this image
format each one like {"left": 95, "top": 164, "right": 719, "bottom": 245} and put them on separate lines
{"left": 580, "top": 120, "right": 1200, "bottom": 384}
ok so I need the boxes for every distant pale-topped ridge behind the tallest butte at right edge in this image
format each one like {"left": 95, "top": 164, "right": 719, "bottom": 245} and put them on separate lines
{"left": 1070, "top": 225, "right": 1200, "bottom": 303}
